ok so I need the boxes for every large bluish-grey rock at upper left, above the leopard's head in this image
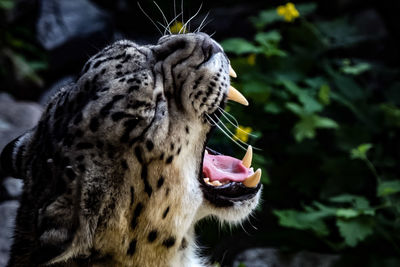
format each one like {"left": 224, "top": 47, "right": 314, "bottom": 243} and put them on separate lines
{"left": 36, "top": 0, "right": 113, "bottom": 73}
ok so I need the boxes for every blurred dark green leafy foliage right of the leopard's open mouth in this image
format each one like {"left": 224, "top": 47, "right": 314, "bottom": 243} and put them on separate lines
{"left": 219, "top": 3, "right": 400, "bottom": 266}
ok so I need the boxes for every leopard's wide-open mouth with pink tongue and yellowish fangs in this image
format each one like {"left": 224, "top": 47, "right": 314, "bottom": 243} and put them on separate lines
{"left": 200, "top": 68, "right": 261, "bottom": 207}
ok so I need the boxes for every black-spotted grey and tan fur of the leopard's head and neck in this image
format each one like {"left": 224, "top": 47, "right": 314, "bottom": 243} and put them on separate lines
{"left": 2, "top": 33, "right": 259, "bottom": 267}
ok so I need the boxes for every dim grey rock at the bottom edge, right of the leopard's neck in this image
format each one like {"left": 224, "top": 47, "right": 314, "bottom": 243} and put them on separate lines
{"left": 233, "top": 248, "right": 339, "bottom": 267}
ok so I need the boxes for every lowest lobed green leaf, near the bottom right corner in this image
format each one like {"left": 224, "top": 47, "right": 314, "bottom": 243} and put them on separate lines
{"left": 336, "top": 217, "right": 373, "bottom": 247}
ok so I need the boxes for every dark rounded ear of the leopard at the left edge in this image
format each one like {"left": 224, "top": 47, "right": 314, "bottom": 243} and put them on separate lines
{"left": 0, "top": 133, "right": 30, "bottom": 178}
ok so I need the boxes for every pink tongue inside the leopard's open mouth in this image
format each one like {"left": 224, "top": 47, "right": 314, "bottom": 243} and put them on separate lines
{"left": 203, "top": 153, "right": 254, "bottom": 182}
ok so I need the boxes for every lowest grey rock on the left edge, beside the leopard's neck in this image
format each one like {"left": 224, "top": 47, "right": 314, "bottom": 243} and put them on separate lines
{"left": 0, "top": 200, "right": 19, "bottom": 266}
